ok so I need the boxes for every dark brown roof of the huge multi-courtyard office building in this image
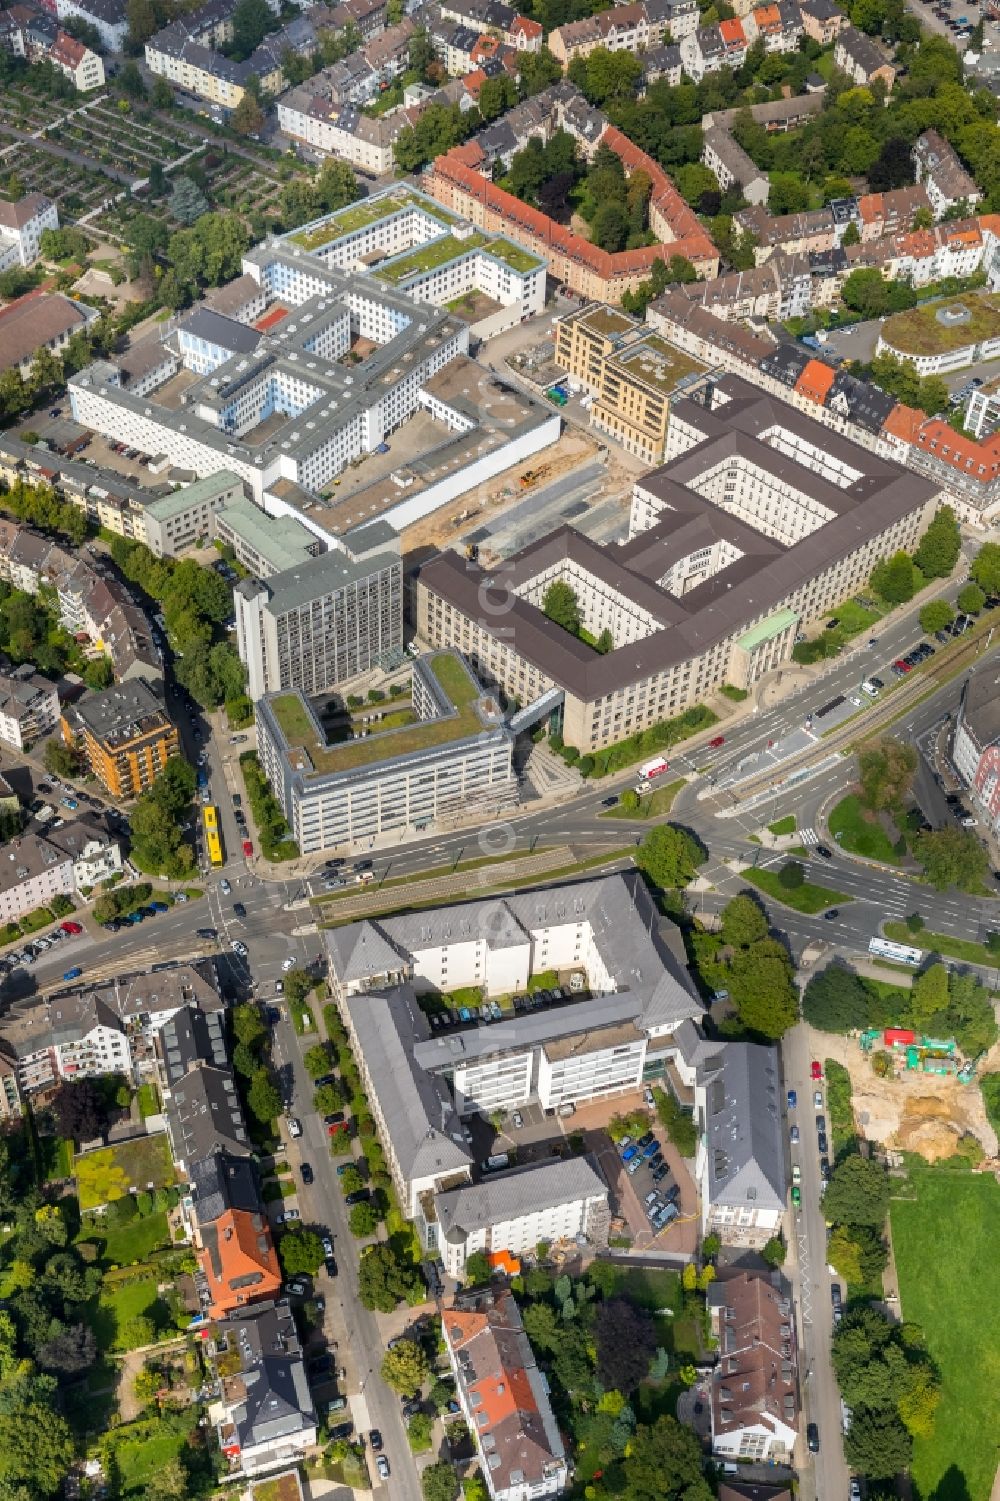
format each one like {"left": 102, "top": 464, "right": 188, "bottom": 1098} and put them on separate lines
{"left": 420, "top": 375, "right": 935, "bottom": 702}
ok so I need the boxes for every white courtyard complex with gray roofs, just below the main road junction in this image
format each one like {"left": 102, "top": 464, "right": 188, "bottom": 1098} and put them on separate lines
{"left": 324, "top": 875, "right": 701, "bottom": 1212}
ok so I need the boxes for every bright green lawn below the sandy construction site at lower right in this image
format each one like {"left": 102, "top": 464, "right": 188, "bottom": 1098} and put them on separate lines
{"left": 890, "top": 1168, "right": 1000, "bottom": 1501}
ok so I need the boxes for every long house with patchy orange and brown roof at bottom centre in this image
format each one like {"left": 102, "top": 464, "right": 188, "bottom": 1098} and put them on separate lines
{"left": 441, "top": 1288, "right": 569, "bottom": 1501}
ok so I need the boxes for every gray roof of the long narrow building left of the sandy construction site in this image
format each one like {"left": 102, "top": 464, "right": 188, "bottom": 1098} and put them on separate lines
{"left": 696, "top": 1042, "right": 787, "bottom": 1210}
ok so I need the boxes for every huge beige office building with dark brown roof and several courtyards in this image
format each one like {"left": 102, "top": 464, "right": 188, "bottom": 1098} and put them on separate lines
{"left": 417, "top": 375, "right": 940, "bottom": 752}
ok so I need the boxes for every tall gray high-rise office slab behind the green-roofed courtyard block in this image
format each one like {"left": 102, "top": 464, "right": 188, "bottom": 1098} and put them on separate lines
{"left": 234, "top": 527, "right": 402, "bottom": 699}
